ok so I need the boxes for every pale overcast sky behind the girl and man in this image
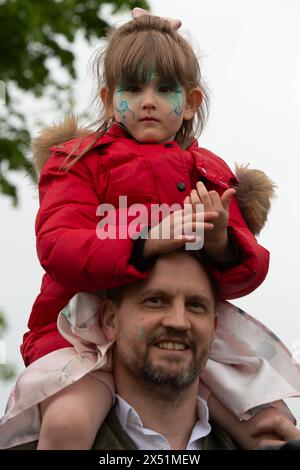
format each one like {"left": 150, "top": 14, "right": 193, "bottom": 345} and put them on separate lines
{"left": 0, "top": 0, "right": 300, "bottom": 420}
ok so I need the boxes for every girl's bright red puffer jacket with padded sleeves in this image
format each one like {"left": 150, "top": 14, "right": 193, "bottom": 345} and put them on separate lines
{"left": 21, "top": 119, "right": 269, "bottom": 365}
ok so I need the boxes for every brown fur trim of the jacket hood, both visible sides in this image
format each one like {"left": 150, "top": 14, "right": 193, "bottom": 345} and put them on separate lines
{"left": 33, "top": 115, "right": 276, "bottom": 235}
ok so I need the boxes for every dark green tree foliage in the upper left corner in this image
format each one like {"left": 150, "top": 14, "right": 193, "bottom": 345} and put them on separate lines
{"left": 0, "top": 0, "right": 148, "bottom": 206}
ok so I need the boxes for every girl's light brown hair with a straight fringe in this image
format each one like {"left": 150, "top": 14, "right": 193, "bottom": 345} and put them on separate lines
{"left": 63, "top": 15, "right": 209, "bottom": 168}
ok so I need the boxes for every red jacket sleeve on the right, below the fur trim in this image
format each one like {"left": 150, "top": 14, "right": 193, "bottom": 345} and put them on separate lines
{"left": 207, "top": 194, "right": 269, "bottom": 300}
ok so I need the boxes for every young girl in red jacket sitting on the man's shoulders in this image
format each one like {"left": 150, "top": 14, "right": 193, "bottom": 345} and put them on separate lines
{"left": 0, "top": 15, "right": 298, "bottom": 449}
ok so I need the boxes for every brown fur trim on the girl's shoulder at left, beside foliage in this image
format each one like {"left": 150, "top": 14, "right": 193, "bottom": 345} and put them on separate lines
{"left": 32, "top": 114, "right": 91, "bottom": 172}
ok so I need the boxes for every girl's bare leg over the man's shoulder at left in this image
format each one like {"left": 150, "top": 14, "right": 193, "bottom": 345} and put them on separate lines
{"left": 37, "top": 375, "right": 113, "bottom": 450}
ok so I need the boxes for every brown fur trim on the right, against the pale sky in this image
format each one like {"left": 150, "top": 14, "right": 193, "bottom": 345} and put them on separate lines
{"left": 235, "top": 164, "right": 277, "bottom": 235}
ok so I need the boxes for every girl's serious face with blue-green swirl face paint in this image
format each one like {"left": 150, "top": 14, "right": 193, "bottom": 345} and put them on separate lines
{"left": 113, "top": 74, "right": 194, "bottom": 143}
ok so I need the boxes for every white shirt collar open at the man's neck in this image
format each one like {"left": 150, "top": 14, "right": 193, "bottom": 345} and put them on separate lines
{"left": 115, "top": 395, "right": 211, "bottom": 450}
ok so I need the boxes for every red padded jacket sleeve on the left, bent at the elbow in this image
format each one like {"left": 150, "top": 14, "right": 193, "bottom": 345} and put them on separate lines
{"left": 36, "top": 153, "right": 147, "bottom": 291}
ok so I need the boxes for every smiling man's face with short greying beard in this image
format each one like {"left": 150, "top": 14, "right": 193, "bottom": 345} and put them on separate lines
{"left": 106, "top": 253, "right": 215, "bottom": 389}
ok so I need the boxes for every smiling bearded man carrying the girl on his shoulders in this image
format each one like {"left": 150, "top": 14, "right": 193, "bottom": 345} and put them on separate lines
{"left": 6, "top": 252, "right": 299, "bottom": 450}
